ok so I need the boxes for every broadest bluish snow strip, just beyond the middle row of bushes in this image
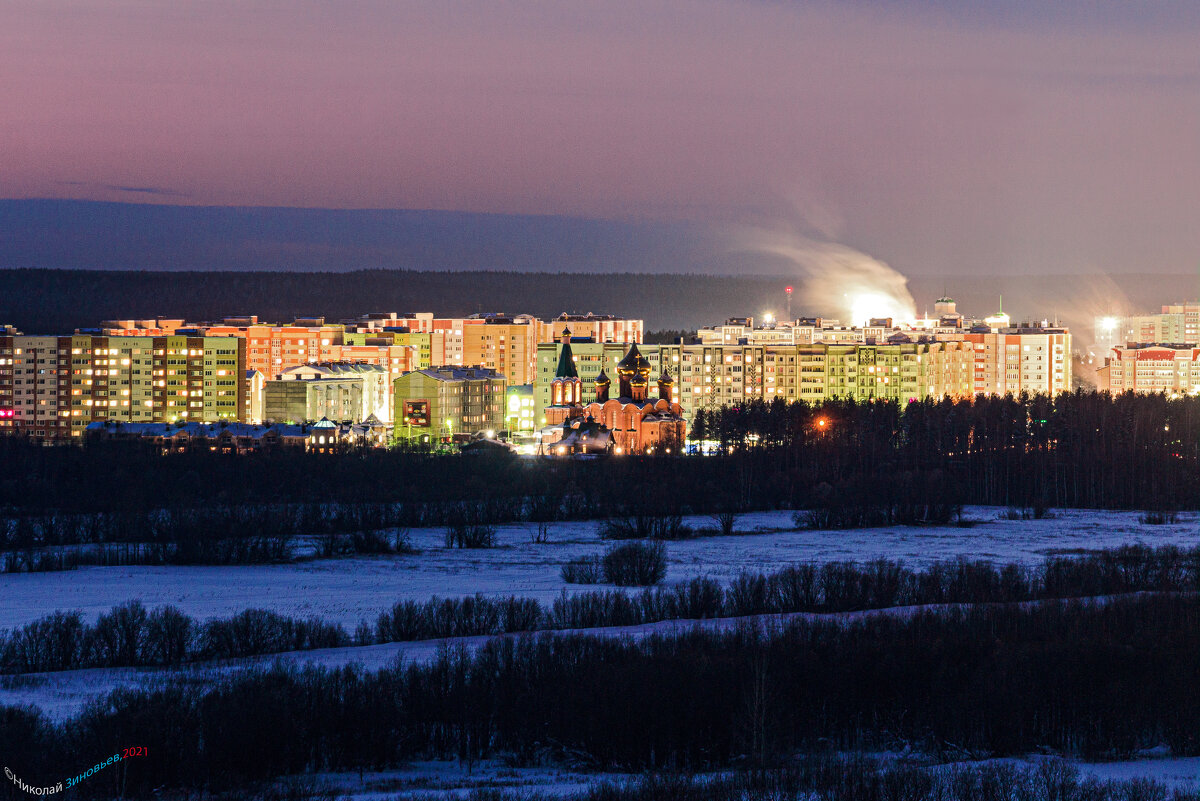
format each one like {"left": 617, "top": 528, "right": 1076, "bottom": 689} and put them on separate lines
{"left": 0, "top": 507, "right": 1200, "bottom": 630}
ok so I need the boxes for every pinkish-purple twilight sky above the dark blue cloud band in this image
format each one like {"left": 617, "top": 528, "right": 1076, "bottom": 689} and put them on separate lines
{"left": 0, "top": 0, "right": 1200, "bottom": 276}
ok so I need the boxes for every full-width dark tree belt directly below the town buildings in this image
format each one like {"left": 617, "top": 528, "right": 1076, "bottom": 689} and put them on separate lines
{"left": 0, "top": 392, "right": 1200, "bottom": 515}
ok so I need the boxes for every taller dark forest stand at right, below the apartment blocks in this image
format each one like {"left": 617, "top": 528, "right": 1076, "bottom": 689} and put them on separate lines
{"left": 689, "top": 391, "right": 1200, "bottom": 510}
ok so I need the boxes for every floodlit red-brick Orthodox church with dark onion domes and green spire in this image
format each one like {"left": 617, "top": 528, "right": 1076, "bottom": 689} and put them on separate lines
{"left": 542, "top": 329, "right": 688, "bottom": 454}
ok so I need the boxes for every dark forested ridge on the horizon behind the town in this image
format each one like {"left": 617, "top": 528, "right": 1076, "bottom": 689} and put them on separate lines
{"left": 0, "top": 263, "right": 1196, "bottom": 335}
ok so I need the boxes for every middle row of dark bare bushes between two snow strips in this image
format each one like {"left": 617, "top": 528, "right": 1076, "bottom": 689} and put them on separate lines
{"left": 0, "top": 543, "right": 1200, "bottom": 674}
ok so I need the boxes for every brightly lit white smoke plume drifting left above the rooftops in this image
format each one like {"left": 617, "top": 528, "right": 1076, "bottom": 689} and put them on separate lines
{"left": 737, "top": 229, "right": 917, "bottom": 325}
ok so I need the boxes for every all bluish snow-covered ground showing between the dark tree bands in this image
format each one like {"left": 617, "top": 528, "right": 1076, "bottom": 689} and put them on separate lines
{"left": 0, "top": 507, "right": 1200, "bottom": 801}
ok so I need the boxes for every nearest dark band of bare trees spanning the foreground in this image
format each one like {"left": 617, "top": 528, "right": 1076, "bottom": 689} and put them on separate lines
{"left": 7, "top": 596, "right": 1200, "bottom": 796}
